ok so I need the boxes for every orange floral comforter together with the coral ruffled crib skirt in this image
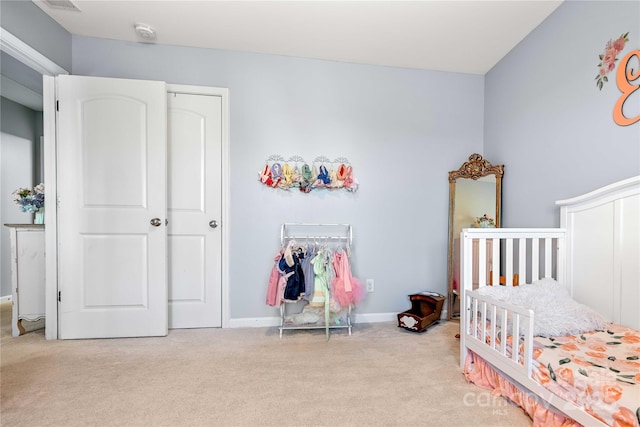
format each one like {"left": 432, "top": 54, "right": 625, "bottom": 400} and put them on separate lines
{"left": 465, "top": 324, "right": 640, "bottom": 427}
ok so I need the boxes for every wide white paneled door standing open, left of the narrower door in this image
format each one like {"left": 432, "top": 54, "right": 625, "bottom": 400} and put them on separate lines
{"left": 57, "top": 76, "right": 168, "bottom": 338}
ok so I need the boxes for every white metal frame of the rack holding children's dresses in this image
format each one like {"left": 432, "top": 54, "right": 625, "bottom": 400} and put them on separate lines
{"left": 279, "top": 222, "right": 353, "bottom": 339}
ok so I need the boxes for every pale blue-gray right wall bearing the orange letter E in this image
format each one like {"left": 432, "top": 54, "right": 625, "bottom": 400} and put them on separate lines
{"left": 484, "top": 1, "right": 640, "bottom": 227}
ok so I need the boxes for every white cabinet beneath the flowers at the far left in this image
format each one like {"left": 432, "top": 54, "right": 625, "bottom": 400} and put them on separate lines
{"left": 5, "top": 224, "right": 45, "bottom": 337}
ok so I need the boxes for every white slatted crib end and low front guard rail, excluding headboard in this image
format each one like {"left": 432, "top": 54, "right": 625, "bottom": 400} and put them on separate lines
{"left": 460, "top": 228, "right": 605, "bottom": 426}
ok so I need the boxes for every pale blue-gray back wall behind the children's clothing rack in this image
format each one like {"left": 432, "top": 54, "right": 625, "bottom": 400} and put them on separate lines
{"left": 73, "top": 36, "right": 484, "bottom": 318}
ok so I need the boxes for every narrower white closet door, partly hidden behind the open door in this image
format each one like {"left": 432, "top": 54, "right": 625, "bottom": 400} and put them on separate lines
{"left": 168, "top": 92, "right": 222, "bottom": 328}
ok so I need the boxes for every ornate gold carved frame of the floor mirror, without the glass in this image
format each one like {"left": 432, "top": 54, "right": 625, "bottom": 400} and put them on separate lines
{"left": 447, "top": 153, "right": 504, "bottom": 320}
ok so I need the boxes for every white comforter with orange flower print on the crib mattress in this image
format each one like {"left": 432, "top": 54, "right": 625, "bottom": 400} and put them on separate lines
{"left": 533, "top": 324, "right": 640, "bottom": 427}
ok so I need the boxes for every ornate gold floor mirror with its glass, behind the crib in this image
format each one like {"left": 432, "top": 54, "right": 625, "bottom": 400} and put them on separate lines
{"left": 447, "top": 154, "right": 504, "bottom": 319}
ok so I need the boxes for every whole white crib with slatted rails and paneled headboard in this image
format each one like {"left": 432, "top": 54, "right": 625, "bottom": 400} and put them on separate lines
{"left": 460, "top": 177, "right": 640, "bottom": 426}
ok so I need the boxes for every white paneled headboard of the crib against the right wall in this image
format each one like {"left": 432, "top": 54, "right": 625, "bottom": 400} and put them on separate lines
{"left": 556, "top": 176, "right": 640, "bottom": 329}
